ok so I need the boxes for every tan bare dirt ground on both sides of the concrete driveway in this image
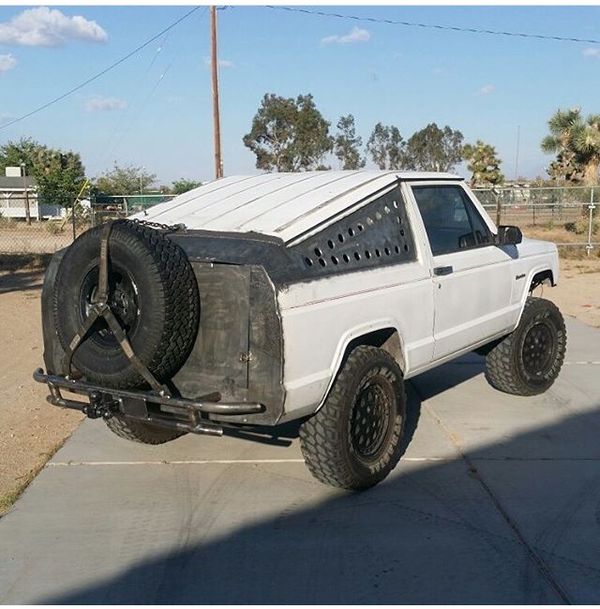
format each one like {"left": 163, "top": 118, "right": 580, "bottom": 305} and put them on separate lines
{"left": 0, "top": 257, "right": 600, "bottom": 516}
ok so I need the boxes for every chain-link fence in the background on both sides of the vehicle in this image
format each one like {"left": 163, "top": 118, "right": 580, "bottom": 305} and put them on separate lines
{"left": 0, "top": 186, "right": 600, "bottom": 255}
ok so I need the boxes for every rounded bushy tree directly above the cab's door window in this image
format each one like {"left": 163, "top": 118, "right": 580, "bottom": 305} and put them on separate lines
{"left": 405, "top": 123, "right": 463, "bottom": 171}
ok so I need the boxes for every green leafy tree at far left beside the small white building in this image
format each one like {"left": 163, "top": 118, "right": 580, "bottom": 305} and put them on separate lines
{"left": 0, "top": 138, "right": 85, "bottom": 207}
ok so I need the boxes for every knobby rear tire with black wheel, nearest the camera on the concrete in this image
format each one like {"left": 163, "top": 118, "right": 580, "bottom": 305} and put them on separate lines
{"left": 300, "top": 346, "right": 406, "bottom": 490}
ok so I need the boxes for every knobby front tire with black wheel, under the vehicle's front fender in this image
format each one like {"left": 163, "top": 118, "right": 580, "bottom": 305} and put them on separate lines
{"left": 485, "top": 297, "right": 567, "bottom": 396}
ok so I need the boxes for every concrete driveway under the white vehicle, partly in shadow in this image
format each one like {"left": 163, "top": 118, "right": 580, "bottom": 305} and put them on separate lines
{"left": 0, "top": 321, "right": 600, "bottom": 603}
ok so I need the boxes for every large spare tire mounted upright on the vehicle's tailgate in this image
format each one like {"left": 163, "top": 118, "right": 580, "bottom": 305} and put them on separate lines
{"left": 54, "top": 220, "right": 200, "bottom": 389}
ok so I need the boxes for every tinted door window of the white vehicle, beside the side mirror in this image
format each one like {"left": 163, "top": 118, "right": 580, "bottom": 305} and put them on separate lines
{"left": 412, "top": 185, "right": 492, "bottom": 256}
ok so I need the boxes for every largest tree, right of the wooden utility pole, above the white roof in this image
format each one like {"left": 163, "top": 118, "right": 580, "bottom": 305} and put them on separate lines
{"left": 243, "top": 93, "right": 333, "bottom": 171}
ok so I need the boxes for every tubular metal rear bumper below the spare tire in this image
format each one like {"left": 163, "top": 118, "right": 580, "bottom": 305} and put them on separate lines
{"left": 33, "top": 368, "right": 265, "bottom": 435}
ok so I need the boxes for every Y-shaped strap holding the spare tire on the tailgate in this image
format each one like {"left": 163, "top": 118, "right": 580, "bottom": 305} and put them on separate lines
{"left": 63, "top": 220, "right": 169, "bottom": 396}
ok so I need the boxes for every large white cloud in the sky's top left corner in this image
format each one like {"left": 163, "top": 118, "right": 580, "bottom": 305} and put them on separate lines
{"left": 0, "top": 6, "right": 108, "bottom": 47}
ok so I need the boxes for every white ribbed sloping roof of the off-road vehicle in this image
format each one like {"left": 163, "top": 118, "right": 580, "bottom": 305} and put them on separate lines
{"left": 133, "top": 170, "right": 461, "bottom": 242}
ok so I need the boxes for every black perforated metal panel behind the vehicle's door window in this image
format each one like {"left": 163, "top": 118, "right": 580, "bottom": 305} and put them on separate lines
{"left": 293, "top": 188, "right": 416, "bottom": 275}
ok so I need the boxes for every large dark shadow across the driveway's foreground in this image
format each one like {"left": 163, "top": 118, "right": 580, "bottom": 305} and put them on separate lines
{"left": 39, "top": 376, "right": 600, "bottom": 604}
